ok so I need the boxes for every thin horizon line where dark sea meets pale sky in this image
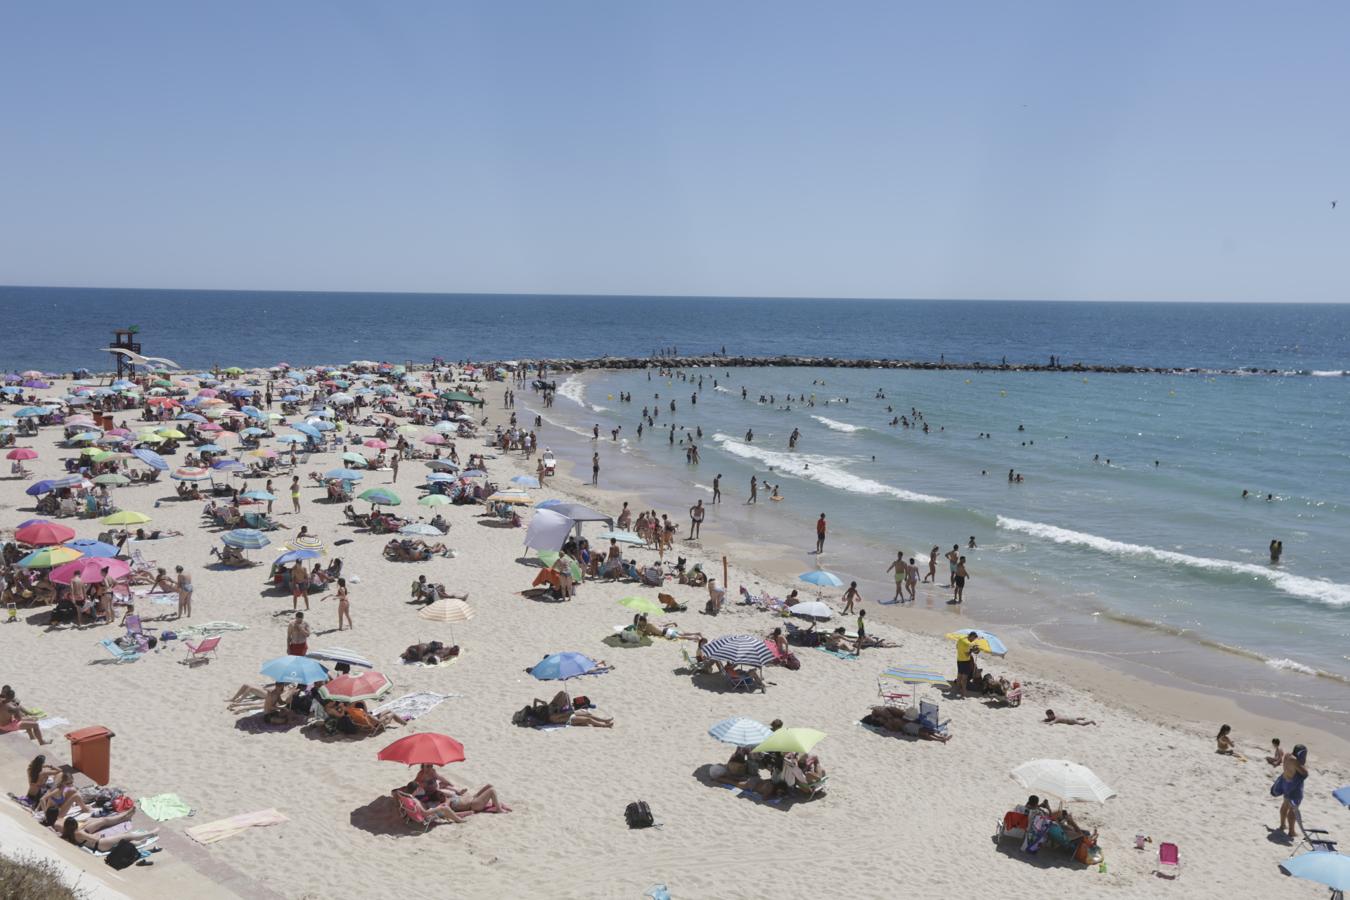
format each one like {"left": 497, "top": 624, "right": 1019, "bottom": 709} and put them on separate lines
{"left": 0, "top": 285, "right": 1350, "bottom": 306}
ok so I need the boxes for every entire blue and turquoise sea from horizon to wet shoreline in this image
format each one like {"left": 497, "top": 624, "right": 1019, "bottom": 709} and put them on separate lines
{"left": 0, "top": 287, "right": 1350, "bottom": 734}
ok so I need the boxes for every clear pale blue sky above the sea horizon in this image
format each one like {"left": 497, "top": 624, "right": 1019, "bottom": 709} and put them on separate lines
{"left": 0, "top": 0, "right": 1350, "bottom": 301}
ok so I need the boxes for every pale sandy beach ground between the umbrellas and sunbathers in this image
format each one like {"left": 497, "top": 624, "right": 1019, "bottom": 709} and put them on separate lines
{"left": 0, "top": 367, "right": 1350, "bottom": 899}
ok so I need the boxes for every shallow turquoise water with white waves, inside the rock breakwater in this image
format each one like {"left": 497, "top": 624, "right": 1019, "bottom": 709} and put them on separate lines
{"left": 531, "top": 368, "right": 1350, "bottom": 712}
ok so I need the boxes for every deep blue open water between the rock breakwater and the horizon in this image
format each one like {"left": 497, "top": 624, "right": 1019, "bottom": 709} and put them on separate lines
{"left": 0, "top": 287, "right": 1350, "bottom": 371}
